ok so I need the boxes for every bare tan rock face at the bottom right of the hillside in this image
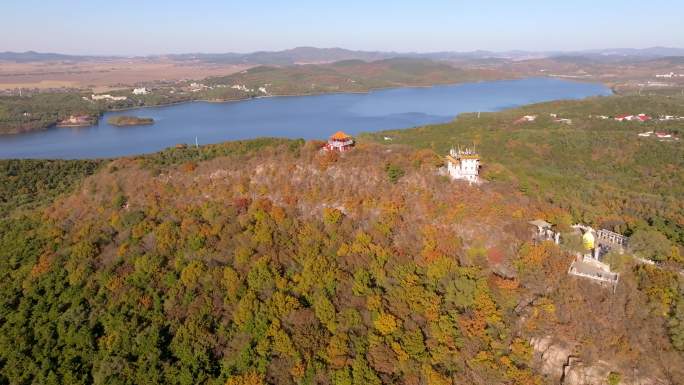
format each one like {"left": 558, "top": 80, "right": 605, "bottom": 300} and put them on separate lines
{"left": 530, "top": 336, "right": 674, "bottom": 385}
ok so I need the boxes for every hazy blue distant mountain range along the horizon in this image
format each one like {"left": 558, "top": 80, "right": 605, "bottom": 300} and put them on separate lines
{"left": 0, "top": 47, "right": 684, "bottom": 65}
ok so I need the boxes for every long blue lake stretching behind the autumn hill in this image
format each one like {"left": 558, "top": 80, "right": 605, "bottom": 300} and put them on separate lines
{"left": 0, "top": 78, "right": 611, "bottom": 159}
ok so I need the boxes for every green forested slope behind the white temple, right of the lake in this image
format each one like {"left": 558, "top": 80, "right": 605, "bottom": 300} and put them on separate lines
{"left": 367, "top": 96, "right": 684, "bottom": 246}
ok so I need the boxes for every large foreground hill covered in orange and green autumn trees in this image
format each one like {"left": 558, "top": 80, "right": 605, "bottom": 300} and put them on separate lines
{"left": 0, "top": 134, "right": 684, "bottom": 385}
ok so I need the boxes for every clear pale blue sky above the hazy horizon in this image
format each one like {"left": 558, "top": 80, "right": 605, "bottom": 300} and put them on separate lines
{"left": 0, "top": 0, "right": 684, "bottom": 55}
